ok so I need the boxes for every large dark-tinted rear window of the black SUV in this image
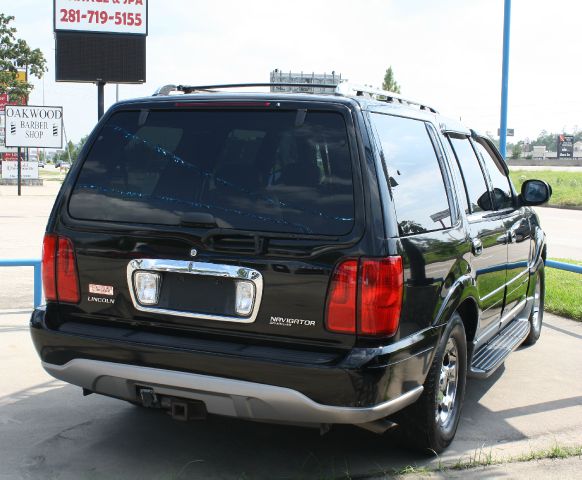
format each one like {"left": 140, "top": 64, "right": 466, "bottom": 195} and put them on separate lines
{"left": 69, "top": 110, "right": 354, "bottom": 235}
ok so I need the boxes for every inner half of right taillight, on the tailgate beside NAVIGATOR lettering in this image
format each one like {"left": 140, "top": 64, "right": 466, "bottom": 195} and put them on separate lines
{"left": 325, "top": 260, "right": 358, "bottom": 333}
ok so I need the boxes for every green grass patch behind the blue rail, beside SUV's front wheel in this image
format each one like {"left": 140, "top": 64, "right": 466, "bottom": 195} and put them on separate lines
{"left": 545, "top": 258, "right": 582, "bottom": 322}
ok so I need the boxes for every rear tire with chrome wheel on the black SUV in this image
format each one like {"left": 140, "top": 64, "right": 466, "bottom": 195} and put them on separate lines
{"left": 396, "top": 312, "right": 467, "bottom": 453}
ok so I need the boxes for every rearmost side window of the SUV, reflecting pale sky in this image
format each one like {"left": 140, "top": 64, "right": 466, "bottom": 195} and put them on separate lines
{"left": 371, "top": 113, "right": 451, "bottom": 235}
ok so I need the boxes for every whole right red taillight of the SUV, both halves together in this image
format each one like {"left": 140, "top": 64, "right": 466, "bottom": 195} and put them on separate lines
{"left": 325, "top": 257, "right": 404, "bottom": 336}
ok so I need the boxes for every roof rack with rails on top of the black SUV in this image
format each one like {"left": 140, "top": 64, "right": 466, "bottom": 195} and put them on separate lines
{"left": 154, "top": 82, "right": 438, "bottom": 113}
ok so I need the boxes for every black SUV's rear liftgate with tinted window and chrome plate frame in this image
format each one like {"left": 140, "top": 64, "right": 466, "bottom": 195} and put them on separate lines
{"left": 58, "top": 102, "right": 364, "bottom": 347}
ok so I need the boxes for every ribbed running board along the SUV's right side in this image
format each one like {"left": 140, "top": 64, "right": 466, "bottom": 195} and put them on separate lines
{"left": 469, "top": 318, "right": 530, "bottom": 378}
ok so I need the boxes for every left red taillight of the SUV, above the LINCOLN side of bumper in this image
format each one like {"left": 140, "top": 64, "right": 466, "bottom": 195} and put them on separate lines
{"left": 42, "top": 234, "right": 81, "bottom": 303}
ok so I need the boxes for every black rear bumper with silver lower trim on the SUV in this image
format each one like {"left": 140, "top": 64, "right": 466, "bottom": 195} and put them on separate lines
{"left": 31, "top": 306, "right": 441, "bottom": 423}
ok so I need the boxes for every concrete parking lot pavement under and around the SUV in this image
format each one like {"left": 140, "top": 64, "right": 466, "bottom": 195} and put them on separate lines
{"left": 0, "top": 312, "right": 582, "bottom": 480}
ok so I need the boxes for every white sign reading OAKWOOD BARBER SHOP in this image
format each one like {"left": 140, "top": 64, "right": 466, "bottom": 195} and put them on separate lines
{"left": 5, "top": 105, "right": 63, "bottom": 148}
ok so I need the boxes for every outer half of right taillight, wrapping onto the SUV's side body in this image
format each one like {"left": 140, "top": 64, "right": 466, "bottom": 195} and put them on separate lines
{"left": 359, "top": 257, "right": 404, "bottom": 336}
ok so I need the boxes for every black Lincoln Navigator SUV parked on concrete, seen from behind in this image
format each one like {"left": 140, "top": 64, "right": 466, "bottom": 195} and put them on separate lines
{"left": 31, "top": 84, "right": 551, "bottom": 452}
